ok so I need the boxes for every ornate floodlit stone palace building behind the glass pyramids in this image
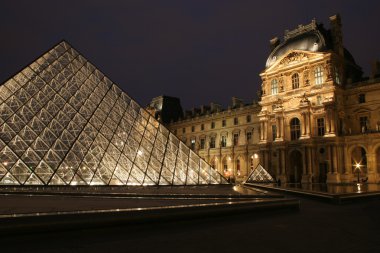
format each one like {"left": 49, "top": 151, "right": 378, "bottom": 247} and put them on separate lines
{"left": 148, "top": 15, "right": 380, "bottom": 183}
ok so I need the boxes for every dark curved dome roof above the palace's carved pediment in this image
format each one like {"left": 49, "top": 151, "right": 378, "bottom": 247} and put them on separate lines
{"left": 265, "top": 30, "right": 327, "bottom": 68}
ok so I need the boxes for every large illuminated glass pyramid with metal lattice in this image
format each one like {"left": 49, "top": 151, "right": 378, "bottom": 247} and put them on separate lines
{"left": 0, "top": 41, "right": 226, "bottom": 185}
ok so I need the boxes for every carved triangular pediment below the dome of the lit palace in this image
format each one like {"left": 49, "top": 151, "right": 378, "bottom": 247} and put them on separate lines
{"left": 265, "top": 50, "right": 323, "bottom": 72}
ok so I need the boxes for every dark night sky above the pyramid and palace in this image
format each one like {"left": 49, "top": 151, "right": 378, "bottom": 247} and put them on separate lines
{"left": 0, "top": 0, "right": 380, "bottom": 109}
